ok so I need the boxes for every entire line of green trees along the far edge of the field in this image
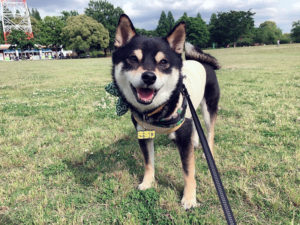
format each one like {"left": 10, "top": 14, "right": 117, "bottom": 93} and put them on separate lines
{"left": 0, "top": 0, "right": 300, "bottom": 56}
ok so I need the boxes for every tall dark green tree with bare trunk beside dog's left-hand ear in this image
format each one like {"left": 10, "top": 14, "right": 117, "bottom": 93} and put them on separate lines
{"left": 85, "top": 0, "right": 124, "bottom": 50}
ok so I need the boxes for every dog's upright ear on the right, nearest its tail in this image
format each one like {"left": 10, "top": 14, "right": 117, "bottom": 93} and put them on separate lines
{"left": 167, "top": 22, "right": 186, "bottom": 54}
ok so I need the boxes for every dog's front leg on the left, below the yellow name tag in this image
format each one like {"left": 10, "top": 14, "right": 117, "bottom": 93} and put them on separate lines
{"left": 139, "top": 139, "right": 154, "bottom": 190}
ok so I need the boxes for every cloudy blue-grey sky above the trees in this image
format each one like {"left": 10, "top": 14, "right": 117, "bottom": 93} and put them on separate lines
{"left": 27, "top": 0, "right": 300, "bottom": 33}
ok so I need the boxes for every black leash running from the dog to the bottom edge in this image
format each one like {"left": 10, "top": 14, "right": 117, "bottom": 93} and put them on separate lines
{"left": 182, "top": 84, "right": 236, "bottom": 225}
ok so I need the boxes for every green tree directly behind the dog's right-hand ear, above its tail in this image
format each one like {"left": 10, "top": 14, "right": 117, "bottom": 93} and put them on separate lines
{"left": 178, "top": 13, "right": 209, "bottom": 48}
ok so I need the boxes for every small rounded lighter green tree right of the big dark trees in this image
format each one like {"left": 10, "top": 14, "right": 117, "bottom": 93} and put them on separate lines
{"left": 255, "top": 21, "right": 282, "bottom": 44}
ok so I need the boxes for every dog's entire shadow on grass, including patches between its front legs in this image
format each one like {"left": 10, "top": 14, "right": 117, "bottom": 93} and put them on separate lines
{"left": 64, "top": 131, "right": 183, "bottom": 191}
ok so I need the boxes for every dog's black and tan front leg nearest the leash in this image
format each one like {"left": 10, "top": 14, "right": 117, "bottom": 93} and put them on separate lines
{"left": 175, "top": 119, "right": 197, "bottom": 209}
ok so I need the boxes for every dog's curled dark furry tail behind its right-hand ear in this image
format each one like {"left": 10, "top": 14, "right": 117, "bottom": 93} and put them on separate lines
{"left": 185, "top": 42, "right": 221, "bottom": 70}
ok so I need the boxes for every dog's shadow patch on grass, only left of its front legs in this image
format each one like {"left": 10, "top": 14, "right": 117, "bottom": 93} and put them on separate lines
{"left": 64, "top": 129, "right": 143, "bottom": 186}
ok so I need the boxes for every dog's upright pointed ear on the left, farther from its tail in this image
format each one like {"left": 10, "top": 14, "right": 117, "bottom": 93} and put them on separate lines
{"left": 115, "top": 14, "right": 136, "bottom": 48}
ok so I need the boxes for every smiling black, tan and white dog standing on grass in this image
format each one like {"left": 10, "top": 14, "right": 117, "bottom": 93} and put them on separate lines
{"left": 112, "top": 14, "right": 220, "bottom": 209}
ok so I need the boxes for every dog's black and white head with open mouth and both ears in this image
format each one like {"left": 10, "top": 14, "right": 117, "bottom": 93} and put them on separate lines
{"left": 113, "top": 15, "right": 186, "bottom": 112}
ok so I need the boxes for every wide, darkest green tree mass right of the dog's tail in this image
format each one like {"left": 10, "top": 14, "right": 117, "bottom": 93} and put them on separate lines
{"left": 209, "top": 11, "right": 255, "bottom": 46}
